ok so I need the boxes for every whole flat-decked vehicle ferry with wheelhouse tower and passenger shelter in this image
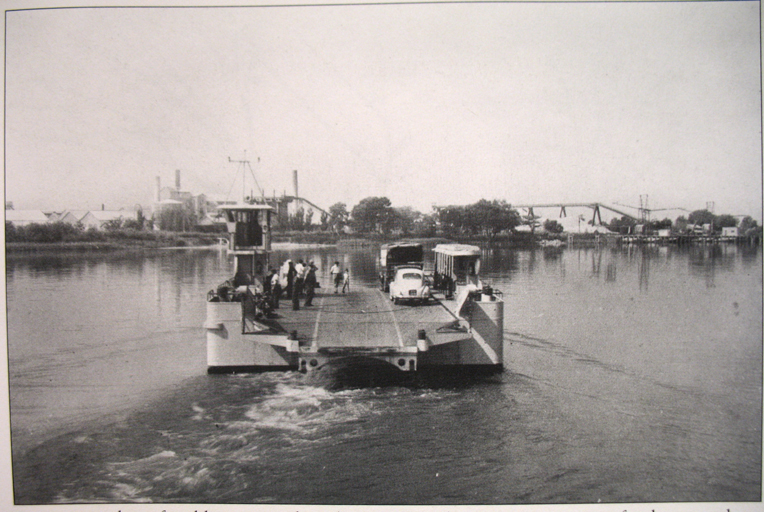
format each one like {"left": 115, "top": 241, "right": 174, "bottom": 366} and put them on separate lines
{"left": 204, "top": 204, "right": 504, "bottom": 374}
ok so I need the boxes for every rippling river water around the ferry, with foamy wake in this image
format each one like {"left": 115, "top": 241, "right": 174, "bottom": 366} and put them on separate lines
{"left": 6, "top": 245, "right": 762, "bottom": 504}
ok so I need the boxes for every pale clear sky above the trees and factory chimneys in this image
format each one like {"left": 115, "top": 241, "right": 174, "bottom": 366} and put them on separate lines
{"left": 4, "top": 2, "right": 762, "bottom": 221}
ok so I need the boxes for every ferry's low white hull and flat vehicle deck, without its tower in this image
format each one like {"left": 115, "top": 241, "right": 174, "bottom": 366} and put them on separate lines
{"left": 205, "top": 288, "right": 504, "bottom": 380}
